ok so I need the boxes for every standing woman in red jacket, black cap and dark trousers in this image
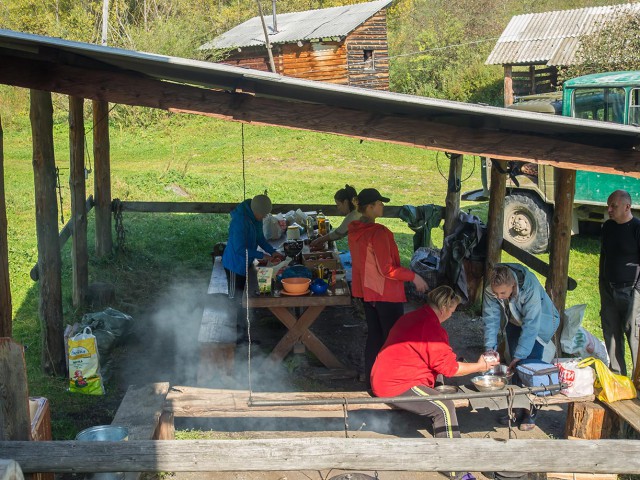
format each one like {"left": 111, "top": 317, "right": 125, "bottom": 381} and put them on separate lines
{"left": 348, "top": 188, "right": 428, "bottom": 384}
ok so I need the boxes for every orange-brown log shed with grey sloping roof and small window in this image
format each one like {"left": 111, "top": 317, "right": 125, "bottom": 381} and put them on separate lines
{"left": 200, "top": 0, "right": 391, "bottom": 90}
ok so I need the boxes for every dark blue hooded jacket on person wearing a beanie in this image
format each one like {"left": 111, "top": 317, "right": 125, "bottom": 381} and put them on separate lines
{"left": 222, "top": 199, "right": 275, "bottom": 277}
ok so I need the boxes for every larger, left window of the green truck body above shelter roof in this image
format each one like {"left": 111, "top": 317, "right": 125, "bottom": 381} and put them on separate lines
{"left": 572, "top": 88, "right": 624, "bottom": 123}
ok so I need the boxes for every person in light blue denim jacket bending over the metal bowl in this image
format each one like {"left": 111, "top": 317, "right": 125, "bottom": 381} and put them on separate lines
{"left": 482, "top": 263, "right": 560, "bottom": 430}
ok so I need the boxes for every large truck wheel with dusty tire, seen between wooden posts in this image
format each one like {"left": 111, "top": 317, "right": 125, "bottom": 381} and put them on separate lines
{"left": 503, "top": 193, "right": 551, "bottom": 253}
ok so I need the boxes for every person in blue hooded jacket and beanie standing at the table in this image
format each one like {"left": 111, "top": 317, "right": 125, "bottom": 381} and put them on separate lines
{"left": 222, "top": 195, "right": 281, "bottom": 343}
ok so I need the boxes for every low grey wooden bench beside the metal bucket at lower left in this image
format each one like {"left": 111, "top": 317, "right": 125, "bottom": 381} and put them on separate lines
{"left": 111, "top": 382, "right": 175, "bottom": 480}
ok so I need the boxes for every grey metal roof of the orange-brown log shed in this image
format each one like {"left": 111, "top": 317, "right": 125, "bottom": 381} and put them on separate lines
{"left": 200, "top": 0, "right": 393, "bottom": 50}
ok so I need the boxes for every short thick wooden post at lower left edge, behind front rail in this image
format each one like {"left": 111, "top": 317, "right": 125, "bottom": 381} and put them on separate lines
{"left": 0, "top": 337, "right": 31, "bottom": 440}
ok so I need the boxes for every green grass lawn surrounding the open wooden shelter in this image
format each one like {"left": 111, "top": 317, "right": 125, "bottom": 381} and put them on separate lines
{"left": 0, "top": 89, "right": 602, "bottom": 439}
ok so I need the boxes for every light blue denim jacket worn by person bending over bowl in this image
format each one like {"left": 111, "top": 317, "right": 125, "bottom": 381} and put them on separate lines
{"left": 482, "top": 263, "right": 560, "bottom": 359}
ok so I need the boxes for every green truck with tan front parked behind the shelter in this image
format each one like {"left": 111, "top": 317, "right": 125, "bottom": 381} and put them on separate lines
{"left": 462, "top": 71, "right": 640, "bottom": 253}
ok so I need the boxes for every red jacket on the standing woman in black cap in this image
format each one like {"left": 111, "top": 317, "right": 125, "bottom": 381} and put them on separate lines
{"left": 348, "top": 220, "right": 416, "bottom": 303}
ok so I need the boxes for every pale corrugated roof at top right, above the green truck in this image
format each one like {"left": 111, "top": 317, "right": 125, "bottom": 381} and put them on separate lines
{"left": 485, "top": 3, "right": 640, "bottom": 66}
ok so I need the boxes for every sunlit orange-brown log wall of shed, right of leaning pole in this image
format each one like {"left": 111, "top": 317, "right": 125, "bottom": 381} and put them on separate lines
{"left": 281, "top": 41, "right": 349, "bottom": 85}
